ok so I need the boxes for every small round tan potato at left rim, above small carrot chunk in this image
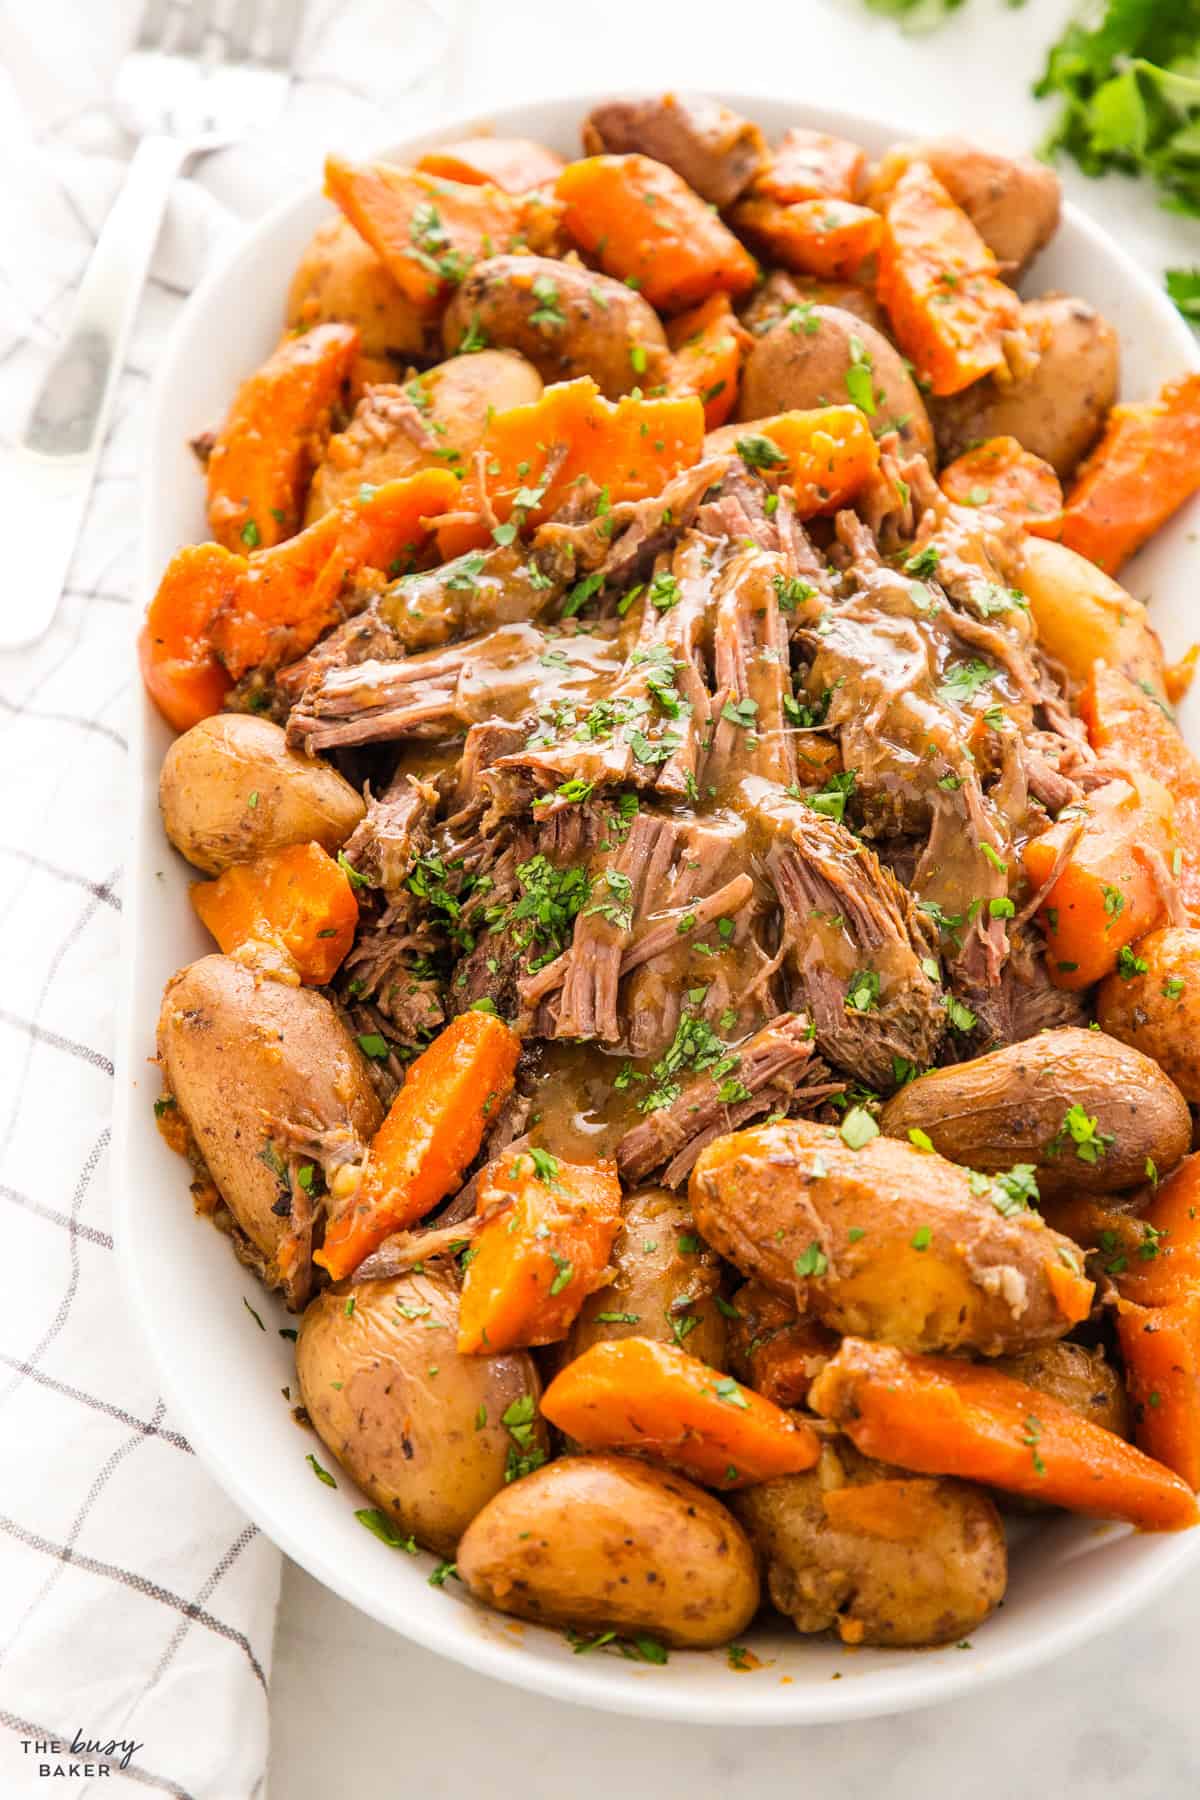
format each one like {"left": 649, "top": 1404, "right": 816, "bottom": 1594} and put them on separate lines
{"left": 158, "top": 713, "right": 367, "bottom": 875}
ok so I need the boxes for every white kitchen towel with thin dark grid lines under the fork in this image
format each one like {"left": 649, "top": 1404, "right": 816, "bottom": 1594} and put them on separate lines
{"left": 0, "top": 0, "right": 464, "bottom": 1800}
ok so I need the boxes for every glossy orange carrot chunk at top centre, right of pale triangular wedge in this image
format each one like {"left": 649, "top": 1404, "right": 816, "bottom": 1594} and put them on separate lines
{"left": 554, "top": 155, "right": 757, "bottom": 313}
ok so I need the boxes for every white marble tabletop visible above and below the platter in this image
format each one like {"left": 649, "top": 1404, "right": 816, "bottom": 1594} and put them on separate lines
{"left": 270, "top": 0, "right": 1200, "bottom": 1800}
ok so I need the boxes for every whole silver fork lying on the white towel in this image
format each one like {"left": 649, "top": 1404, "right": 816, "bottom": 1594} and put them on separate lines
{"left": 0, "top": 0, "right": 302, "bottom": 648}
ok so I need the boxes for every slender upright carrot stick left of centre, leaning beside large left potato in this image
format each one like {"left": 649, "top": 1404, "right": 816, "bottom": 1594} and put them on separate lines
{"left": 313, "top": 1012, "right": 520, "bottom": 1282}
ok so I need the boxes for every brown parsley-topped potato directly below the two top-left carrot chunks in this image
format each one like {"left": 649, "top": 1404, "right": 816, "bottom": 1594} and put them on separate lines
{"left": 443, "top": 256, "right": 667, "bottom": 400}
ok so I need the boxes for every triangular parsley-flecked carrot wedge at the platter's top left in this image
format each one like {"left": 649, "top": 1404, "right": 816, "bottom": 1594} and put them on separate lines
{"left": 326, "top": 157, "right": 560, "bottom": 313}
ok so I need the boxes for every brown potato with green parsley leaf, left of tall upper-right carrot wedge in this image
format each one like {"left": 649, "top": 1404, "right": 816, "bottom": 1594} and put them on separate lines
{"left": 738, "top": 306, "right": 934, "bottom": 459}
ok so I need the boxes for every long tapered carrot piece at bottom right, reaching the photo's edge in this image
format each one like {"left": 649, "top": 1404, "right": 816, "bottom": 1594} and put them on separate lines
{"left": 805, "top": 1337, "right": 1200, "bottom": 1532}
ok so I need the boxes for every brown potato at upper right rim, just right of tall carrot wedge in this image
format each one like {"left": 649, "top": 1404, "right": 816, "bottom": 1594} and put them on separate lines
{"left": 932, "top": 293, "right": 1121, "bottom": 481}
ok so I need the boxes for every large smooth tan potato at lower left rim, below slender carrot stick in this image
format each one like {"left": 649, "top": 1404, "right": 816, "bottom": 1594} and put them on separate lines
{"left": 295, "top": 1269, "right": 549, "bottom": 1557}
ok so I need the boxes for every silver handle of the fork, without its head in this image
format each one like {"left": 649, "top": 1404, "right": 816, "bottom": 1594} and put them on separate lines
{"left": 0, "top": 137, "right": 189, "bottom": 650}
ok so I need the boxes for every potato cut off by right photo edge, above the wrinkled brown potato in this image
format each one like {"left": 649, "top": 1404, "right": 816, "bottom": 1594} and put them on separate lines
{"left": 1096, "top": 925, "right": 1200, "bottom": 1105}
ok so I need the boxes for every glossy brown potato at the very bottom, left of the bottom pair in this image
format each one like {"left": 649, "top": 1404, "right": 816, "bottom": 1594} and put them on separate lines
{"left": 457, "top": 1456, "right": 759, "bottom": 1649}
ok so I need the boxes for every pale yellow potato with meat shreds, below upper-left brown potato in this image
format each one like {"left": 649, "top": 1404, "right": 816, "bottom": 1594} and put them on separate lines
{"left": 306, "top": 349, "right": 542, "bottom": 526}
